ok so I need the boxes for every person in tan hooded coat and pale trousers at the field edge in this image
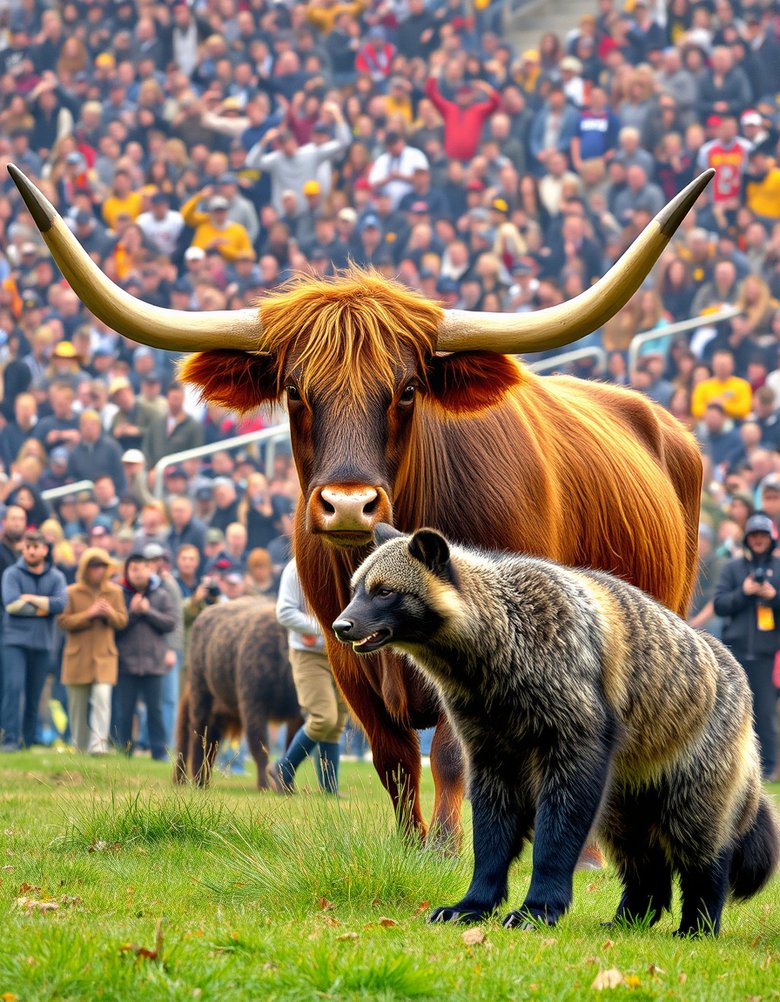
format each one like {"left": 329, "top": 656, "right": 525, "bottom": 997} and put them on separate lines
{"left": 58, "top": 547, "right": 127, "bottom": 755}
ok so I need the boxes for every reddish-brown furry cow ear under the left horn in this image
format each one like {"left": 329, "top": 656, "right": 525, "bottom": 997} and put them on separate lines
{"left": 178, "top": 351, "right": 279, "bottom": 414}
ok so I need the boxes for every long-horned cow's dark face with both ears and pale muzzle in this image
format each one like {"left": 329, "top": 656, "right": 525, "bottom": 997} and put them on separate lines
{"left": 182, "top": 310, "right": 523, "bottom": 547}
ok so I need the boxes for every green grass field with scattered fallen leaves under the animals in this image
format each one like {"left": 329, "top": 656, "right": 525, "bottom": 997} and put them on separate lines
{"left": 0, "top": 750, "right": 780, "bottom": 1002}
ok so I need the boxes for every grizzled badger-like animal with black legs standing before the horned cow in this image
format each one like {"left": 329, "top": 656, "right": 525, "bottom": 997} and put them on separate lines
{"left": 333, "top": 526, "right": 780, "bottom": 936}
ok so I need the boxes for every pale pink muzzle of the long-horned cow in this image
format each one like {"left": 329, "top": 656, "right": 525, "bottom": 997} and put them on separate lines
{"left": 307, "top": 484, "right": 393, "bottom": 546}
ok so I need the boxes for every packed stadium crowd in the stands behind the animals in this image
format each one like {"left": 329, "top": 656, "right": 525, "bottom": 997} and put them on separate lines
{"left": 0, "top": 0, "right": 780, "bottom": 769}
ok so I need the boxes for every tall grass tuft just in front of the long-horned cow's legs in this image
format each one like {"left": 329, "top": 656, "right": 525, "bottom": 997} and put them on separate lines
{"left": 213, "top": 785, "right": 470, "bottom": 915}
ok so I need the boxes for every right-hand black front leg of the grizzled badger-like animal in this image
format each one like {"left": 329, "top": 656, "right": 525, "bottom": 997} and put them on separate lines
{"left": 503, "top": 736, "right": 612, "bottom": 928}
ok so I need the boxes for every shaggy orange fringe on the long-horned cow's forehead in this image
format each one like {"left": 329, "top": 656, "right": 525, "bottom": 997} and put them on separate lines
{"left": 260, "top": 269, "right": 443, "bottom": 401}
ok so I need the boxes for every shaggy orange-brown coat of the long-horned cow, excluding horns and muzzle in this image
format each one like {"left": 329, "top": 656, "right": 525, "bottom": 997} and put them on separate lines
{"left": 182, "top": 262, "right": 702, "bottom": 834}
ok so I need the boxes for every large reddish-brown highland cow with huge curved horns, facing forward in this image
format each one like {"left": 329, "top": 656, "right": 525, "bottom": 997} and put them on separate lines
{"left": 8, "top": 164, "right": 715, "bottom": 844}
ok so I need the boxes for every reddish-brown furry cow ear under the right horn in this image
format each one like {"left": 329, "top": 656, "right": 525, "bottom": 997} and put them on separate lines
{"left": 428, "top": 352, "right": 523, "bottom": 414}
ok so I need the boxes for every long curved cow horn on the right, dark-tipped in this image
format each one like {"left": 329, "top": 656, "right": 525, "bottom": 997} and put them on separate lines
{"left": 436, "top": 168, "right": 715, "bottom": 355}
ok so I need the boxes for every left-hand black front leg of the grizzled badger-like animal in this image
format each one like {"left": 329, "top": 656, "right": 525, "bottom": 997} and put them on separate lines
{"left": 428, "top": 764, "right": 533, "bottom": 922}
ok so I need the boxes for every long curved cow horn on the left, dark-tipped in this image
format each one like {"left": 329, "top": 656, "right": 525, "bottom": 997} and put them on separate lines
{"left": 8, "top": 163, "right": 263, "bottom": 352}
